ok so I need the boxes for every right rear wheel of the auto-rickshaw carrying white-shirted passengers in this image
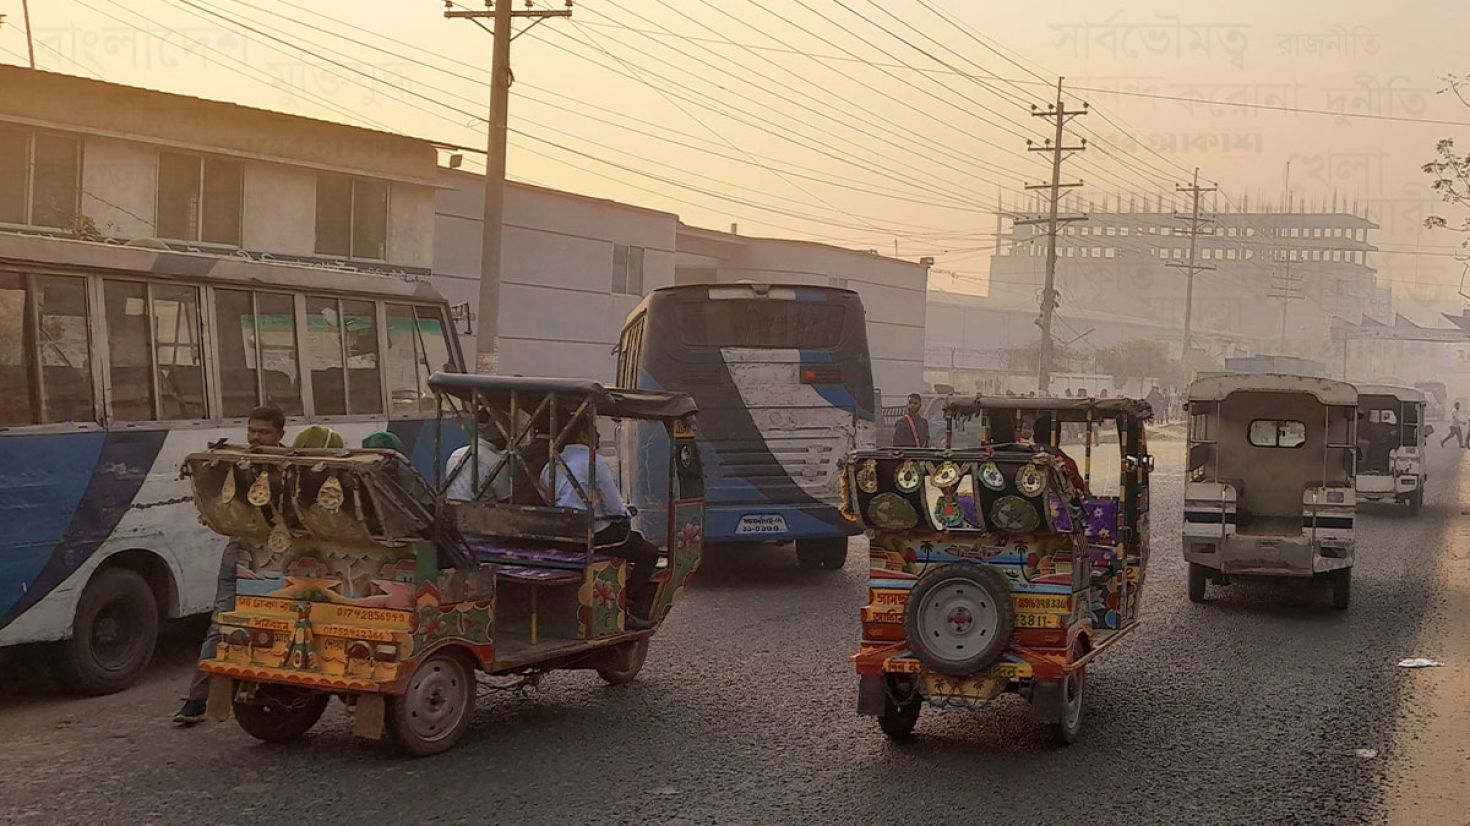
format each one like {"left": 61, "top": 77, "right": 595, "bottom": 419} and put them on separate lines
{"left": 387, "top": 651, "right": 475, "bottom": 757}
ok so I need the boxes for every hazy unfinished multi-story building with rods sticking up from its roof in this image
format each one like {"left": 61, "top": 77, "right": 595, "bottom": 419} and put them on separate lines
{"left": 989, "top": 198, "right": 1392, "bottom": 359}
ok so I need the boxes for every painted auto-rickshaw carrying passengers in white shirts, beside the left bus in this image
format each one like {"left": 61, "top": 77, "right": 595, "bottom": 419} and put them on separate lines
{"left": 185, "top": 373, "right": 704, "bottom": 755}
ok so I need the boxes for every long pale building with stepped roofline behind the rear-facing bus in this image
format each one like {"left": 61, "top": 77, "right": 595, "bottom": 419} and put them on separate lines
{"left": 434, "top": 178, "right": 928, "bottom": 394}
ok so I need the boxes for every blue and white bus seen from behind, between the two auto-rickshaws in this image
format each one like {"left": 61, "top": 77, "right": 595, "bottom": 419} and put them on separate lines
{"left": 619, "top": 282, "right": 875, "bottom": 569}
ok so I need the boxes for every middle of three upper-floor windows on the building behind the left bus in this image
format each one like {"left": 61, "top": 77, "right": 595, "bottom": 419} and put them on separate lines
{"left": 157, "top": 151, "right": 244, "bottom": 247}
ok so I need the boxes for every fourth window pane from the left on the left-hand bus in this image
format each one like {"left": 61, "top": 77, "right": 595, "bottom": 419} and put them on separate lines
{"left": 153, "top": 284, "right": 204, "bottom": 419}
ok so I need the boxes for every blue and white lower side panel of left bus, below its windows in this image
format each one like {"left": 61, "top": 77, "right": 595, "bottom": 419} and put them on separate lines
{"left": 0, "top": 419, "right": 466, "bottom": 645}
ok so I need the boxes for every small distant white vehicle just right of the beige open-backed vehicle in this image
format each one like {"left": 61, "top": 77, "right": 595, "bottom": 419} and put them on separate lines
{"left": 1357, "top": 385, "right": 1433, "bottom": 514}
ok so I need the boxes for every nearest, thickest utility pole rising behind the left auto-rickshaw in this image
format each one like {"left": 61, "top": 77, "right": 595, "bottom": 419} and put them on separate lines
{"left": 444, "top": 0, "right": 572, "bottom": 375}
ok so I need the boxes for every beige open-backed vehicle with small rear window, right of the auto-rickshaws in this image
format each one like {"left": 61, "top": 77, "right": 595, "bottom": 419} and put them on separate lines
{"left": 1183, "top": 375, "right": 1358, "bottom": 608}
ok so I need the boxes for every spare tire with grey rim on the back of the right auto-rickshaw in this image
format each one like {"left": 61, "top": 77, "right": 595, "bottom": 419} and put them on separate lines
{"left": 904, "top": 563, "right": 1016, "bottom": 676}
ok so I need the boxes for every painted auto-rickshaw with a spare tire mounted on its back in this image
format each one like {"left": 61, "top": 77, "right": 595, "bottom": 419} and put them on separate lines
{"left": 844, "top": 397, "right": 1152, "bottom": 744}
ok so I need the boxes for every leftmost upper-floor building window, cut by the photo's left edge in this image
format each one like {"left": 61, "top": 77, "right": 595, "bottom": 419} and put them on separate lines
{"left": 0, "top": 128, "right": 82, "bottom": 228}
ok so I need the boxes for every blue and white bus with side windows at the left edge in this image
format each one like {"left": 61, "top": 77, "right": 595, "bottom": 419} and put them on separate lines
{"left": 0, "top": 238, "right": 463, "bottom": 694}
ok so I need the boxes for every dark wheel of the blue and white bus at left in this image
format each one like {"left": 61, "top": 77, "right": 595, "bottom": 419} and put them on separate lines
{"left": 59, "top": 567, "right": 159, "bottom": 694}
